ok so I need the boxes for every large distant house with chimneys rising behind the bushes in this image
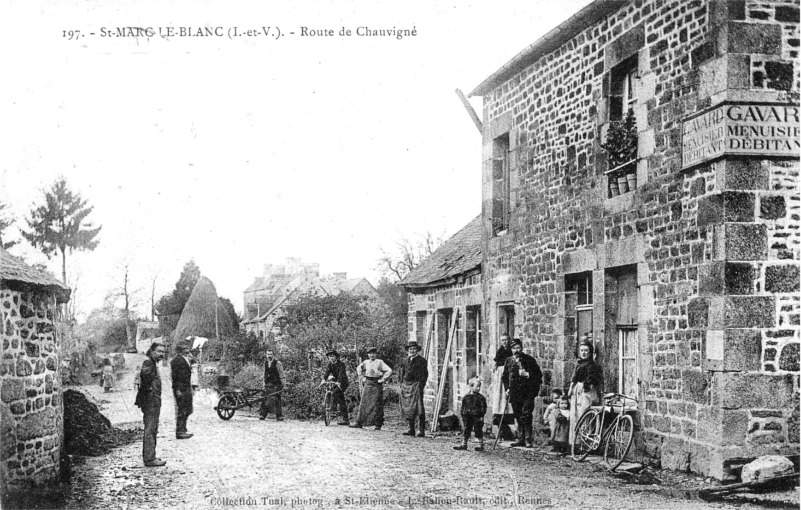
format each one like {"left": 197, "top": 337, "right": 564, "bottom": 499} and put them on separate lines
{"left": 240, "top": 258, "right": 378, "bottom": 337}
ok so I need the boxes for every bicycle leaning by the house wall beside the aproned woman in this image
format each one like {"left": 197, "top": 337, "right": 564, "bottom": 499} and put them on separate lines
{"left": 571, "top": 393, "right": 637, "bottom": 471}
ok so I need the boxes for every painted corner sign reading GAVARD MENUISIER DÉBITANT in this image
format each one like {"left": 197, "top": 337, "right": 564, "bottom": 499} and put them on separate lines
{"left": 681, "top": 104, "right": 801, "bottom": 169}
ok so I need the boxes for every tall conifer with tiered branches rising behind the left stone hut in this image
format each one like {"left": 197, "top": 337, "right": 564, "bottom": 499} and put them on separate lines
{"left": 22, "top": 177, "right": 101, "bottom": 284}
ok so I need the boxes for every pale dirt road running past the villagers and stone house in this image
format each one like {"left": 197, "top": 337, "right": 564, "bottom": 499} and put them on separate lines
{"left": 61, "top": 371, "right": 797, "bottom": 510}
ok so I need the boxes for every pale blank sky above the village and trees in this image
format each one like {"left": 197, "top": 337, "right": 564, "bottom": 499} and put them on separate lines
{"left": 0, "top": 0, "right": 589, "bottom": 320}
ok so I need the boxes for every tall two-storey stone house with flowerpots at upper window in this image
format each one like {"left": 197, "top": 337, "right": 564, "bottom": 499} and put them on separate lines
{"left": 460, "top": 0, "right": 801, "bottom": 479}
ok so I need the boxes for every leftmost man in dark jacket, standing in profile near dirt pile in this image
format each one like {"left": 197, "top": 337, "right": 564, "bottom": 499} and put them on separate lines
{"left": 134, "top": 342, "right": 166, "bottom": 467}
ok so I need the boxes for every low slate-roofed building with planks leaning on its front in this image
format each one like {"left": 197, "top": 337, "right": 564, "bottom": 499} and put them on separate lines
{"left": 399, "top": 216, "right": 482, "bottom": 422}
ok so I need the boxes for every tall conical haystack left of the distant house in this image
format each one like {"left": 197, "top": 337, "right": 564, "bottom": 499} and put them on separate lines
{"left": 173, "top": 276, "right": 236, "bottom": 341}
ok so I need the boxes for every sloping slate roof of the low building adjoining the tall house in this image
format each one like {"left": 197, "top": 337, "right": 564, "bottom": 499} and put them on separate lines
{"left": 399, "top": 215, "right": 482, "bottom": 287}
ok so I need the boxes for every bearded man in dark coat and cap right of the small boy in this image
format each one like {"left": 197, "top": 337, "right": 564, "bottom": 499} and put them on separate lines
{"left": 503, "top": 338, "right": 542, "bottom": 448}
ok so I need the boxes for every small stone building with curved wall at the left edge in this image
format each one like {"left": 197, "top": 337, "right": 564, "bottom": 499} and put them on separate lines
{"left": 0, "top": 248, "right": 70, "bottom": 497}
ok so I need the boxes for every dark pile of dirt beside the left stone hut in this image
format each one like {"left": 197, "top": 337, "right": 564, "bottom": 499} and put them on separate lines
{"left": 63, "top": 389, "right": 142, "bottom": 457}
